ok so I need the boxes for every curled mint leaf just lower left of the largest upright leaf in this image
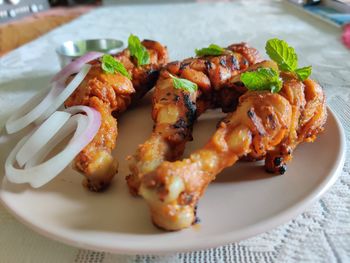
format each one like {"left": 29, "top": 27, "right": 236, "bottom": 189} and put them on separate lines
{"left": 241, "top": 68, "right": 282, "bottom": 93}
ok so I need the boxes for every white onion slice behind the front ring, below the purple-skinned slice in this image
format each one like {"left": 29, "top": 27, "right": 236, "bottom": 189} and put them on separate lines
{"left": 6, "top": 65, "right": 91, "bottom": 134}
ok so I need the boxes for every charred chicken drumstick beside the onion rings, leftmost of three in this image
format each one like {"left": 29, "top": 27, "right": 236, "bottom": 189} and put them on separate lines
{"left": 65, "top": 40, "right": 168, "bottom": 191}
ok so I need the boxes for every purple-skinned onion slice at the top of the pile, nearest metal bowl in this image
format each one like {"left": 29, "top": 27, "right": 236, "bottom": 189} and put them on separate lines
{"left": 52, "top": 51, "right": 103, "bottom": 82}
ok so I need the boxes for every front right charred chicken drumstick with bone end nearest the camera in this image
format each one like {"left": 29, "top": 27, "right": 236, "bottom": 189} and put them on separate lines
{"left": 139, "top": 67, "right": 327, "bottom": 230}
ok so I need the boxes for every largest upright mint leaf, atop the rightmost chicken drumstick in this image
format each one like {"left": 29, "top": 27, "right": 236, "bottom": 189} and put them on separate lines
{"left": 265, "top": 38, "right": 298, "bottom": 72}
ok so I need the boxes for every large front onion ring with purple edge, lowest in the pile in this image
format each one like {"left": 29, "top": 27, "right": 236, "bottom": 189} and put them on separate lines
{"left": 5, "top": 106, "right": 101, "bottom": 188}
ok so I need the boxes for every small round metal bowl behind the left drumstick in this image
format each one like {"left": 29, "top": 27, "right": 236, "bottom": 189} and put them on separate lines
{"left": 56, "top": 39, "right": 124, "bottom": 67}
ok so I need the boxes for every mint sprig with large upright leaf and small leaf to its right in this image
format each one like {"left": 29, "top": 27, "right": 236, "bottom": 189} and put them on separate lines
{"left": 265, "top": 38, "right": 312, "bottom": 81}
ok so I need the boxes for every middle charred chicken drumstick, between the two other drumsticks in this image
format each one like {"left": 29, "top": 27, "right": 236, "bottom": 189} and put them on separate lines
{"left": 127, "top": 43, "right": 260, "bottom": 195}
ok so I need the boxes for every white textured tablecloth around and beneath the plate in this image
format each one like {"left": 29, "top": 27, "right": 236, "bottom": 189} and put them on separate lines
{"left": 0, "top": 1, "right": 350, "bottom": 263}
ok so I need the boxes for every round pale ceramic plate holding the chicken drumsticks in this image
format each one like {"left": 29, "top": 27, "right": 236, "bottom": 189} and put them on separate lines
{"left": 0, "top": 85, "right": 345, "bottom": 254}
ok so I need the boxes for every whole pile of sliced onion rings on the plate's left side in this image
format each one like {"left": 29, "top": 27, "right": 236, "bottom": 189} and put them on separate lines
{"left": 5, "top": 52, "right": 103, "bottom": 187}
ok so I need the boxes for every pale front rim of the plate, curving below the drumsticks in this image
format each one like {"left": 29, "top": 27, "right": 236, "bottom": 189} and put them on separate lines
{"left": 0, "top": 106, "right": 346, "bottom": 255}
